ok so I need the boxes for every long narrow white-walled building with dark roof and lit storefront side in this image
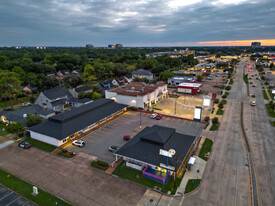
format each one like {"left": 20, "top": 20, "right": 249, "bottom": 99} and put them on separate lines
{"left": 28, "top": 99, "right": 127, "bottom": 146}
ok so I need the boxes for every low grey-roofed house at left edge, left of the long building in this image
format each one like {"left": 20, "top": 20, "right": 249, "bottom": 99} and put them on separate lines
{"left": 0, "top": 105, "right": 55, "bottom": 125}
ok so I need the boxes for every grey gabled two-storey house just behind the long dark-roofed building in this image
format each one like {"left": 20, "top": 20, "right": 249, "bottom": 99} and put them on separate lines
{"left": 36, "top": 87, "right": 92, "bottom": 111}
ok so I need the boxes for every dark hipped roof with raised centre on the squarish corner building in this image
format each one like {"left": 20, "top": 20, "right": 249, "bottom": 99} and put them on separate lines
{"left": 116, "top": 125, "right": 196, "bottom": 171}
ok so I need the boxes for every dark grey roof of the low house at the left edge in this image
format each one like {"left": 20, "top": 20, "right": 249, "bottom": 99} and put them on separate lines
{"left": 0, "top": 104, "right": 54, "bottom": 125}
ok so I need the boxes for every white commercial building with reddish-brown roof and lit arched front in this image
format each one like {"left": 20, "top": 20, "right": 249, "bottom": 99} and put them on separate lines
{"left": 105, "top": 82, "right": 168, "bottom": 109}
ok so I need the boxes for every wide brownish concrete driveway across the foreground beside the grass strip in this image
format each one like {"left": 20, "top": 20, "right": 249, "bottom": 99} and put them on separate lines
{"left": 0, "top": 144, "right": 146, "bottom": 206}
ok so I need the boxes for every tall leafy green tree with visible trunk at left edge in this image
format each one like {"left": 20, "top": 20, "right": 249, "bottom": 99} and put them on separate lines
{"left": 0, "top": 70, "right": 22, "bottom": 109}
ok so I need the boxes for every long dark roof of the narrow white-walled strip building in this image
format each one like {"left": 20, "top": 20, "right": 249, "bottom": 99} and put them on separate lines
{"left": 29, "top": 99, "right": 126, "bottom": 140}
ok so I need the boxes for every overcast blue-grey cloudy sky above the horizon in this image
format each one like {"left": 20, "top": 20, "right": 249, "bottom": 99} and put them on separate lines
{"left": 0, "top": 0, "right": 275, "bottom": 46}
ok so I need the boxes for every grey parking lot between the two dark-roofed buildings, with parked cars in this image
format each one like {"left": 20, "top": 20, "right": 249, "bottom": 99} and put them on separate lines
{"left": 66, "top": 111, "right": 204, "bottom": 164}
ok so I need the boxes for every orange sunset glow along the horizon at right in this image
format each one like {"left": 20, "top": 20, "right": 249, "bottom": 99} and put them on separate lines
{"left": 198, "top": 39, "right": 275, "bottom": 46}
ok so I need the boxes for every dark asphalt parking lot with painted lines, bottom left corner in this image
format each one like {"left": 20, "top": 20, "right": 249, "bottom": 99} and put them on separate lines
{"left": 0, "top": 184, "right": 35, "bottom": 206}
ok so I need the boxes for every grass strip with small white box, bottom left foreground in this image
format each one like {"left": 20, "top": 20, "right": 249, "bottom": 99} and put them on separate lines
{"left": 0, "top": 170, "right": 71, "bottom": 206}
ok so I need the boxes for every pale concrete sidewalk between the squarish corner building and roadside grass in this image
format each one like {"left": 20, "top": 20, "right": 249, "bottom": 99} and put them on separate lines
{"left": 176, "top": 156, "right": 206, "bottom": 194}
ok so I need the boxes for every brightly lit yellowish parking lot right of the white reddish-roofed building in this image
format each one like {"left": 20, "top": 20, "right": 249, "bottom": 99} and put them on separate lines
{"left": 154, "top": 94, "right": 211, "bottom": 119}
